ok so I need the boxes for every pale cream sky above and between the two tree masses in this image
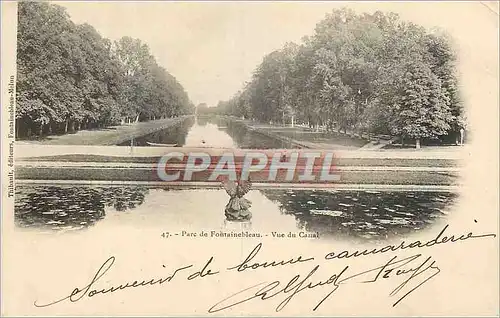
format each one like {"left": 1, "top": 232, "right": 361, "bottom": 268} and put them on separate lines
{"left": 54, "top": 1, "right": 498, "bottom": 106}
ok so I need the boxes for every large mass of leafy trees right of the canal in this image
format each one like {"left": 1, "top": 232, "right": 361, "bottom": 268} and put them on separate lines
{"left": 208, "top": 9, "right": 465, "bottom": 145}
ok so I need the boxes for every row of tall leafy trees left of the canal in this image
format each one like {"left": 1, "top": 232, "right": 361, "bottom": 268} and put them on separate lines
{"left": 16, "top": 1, "right": 194, "bottom": 138}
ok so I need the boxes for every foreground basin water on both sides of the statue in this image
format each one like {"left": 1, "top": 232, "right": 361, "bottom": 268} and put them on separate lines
{"left": 15, "top": 185, "right": 456, "bottom": 240}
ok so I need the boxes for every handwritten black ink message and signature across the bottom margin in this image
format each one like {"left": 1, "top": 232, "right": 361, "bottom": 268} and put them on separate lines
{"left": 34, "top": 225, "right": 496, "bottom": 313}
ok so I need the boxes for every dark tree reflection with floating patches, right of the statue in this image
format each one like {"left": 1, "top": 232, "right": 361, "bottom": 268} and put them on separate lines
{"left": 262, "top": 190, "right": 457, "bottom": 239}
